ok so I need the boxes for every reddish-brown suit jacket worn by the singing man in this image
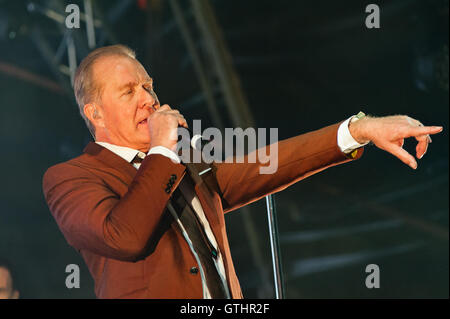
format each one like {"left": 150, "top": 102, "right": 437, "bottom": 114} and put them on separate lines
{"left": 43, "top": 124, "right": 362, "bottom": 298}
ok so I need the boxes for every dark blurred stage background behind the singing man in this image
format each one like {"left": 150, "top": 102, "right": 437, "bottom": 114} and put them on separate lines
{"left": 0, "top": 0, "right": 449, "bottom": 298}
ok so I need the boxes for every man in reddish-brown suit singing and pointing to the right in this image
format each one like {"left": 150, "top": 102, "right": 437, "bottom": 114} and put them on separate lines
{"left": 43, "top": 45, "right": 442, "bottom": 298}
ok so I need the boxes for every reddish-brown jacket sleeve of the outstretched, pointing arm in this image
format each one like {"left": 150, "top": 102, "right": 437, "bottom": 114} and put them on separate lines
{"left": 215, "top": 123, "right": 363, "bottom": 212}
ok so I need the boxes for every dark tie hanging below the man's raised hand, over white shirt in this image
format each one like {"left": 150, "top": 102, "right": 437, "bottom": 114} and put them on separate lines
{"left": 170, "top": 174, "right": 227, "bottom": 299}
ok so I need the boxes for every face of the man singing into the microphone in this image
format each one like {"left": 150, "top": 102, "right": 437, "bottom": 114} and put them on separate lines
{"left": 93, "top": 56, "right": 160, "bottom": 152}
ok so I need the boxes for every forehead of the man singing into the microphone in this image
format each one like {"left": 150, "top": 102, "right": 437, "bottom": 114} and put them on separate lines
{"left": 93, "top": 56, "right": 150, "bottom": 86}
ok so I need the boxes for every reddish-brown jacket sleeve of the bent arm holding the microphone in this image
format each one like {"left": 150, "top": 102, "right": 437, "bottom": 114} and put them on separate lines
{"left": 43, "top": 154, "right": 185, "bottom": 261}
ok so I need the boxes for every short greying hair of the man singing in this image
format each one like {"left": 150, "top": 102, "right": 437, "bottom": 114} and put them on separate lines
{"left": 73, "top": 44, "right": 136, "bottom": 138}
